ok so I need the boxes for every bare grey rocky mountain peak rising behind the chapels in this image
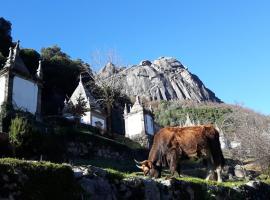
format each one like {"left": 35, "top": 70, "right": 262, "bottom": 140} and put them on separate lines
{"left": 98, "top": 57, "right": 221, "bottom": 102}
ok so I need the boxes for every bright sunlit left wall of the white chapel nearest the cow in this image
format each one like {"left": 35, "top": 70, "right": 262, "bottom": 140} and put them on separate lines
{"left": 125, "top": 113, "right": 144, "bottom": 137}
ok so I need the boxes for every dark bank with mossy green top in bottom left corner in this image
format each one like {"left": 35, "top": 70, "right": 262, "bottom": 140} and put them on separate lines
{"left": 0, "top": 158, "right": 81, "bottom": 200}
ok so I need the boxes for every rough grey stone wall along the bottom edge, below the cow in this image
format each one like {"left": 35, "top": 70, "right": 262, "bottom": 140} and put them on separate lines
{"left": 73, "top": 166, "right": 270, "bottom": 200}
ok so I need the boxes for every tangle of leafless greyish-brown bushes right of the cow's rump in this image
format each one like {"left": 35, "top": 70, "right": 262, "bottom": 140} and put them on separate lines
{"left": 220, "top": 106, "right": 270, "bottom": 160}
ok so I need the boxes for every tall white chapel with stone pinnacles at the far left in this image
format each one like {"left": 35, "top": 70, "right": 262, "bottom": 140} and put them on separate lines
{"left": 0, "top": 41, "right": 43, "bottom": 119}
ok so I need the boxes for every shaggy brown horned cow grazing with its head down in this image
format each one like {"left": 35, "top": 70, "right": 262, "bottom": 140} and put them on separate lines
{"left": 137, "top": 125, "right": 224, "bottom": 182}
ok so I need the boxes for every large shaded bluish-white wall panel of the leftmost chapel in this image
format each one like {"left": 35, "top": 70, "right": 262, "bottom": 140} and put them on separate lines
{"left": 12, "top": 76, "right": 38, "bottom": 114}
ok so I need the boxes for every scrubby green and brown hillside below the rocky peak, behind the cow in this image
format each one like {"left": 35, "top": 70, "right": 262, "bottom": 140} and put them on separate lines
{"left": 149, "top": 101, "right": 270, "bottom": 159}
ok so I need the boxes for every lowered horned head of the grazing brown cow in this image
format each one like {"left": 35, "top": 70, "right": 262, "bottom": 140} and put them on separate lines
{"left": 135, "top": 160, "right": 161, "bottom": 178}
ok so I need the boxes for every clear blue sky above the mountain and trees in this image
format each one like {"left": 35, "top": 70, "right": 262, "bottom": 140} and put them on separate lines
{"left": 0, "top": 0, "right": 270, "bottom": 114}
